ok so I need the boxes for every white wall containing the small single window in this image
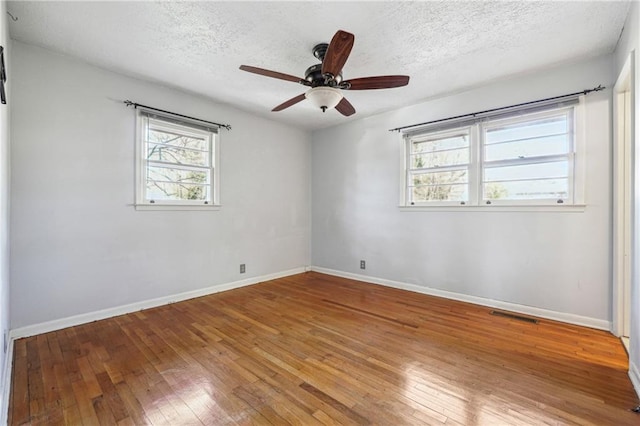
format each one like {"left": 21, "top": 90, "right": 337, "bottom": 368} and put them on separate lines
{"left": 11, "top": 42, "right": 310, "bottom": 329}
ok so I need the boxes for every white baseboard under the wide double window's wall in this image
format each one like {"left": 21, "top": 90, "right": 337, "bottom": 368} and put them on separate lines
{"left": 311, "top": 266, "right": 611, "bottom": 331}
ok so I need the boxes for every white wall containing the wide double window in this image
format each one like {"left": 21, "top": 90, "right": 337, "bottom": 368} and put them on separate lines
{"left": 312, "top": 56, "right": 613, "bottom": 324}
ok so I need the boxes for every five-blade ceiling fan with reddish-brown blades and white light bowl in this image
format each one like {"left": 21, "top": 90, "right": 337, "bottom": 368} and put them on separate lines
{"left": 240, "top": 30, "right": 409, "bottom": 117}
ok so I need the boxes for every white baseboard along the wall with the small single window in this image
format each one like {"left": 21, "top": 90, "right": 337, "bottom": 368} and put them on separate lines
{"left": 11, "top": 267, "right": 306, "bottom": 340}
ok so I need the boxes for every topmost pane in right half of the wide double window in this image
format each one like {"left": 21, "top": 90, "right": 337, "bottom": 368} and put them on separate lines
{"left": 485, "top": 114, "right": 569, "bottom": 144}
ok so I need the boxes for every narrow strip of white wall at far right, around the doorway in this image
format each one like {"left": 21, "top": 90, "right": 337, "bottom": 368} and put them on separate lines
{"left": 614, "top": 2, "right": 640, "bottom": 395}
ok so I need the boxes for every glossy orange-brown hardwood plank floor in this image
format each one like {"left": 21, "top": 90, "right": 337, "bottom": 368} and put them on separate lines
{"left": 9, "top": 272, "right": 640, "bottom": 425}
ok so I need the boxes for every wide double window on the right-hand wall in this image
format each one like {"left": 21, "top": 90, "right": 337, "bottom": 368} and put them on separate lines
{"left": 403, "top": 106, "right": 579, "bottom": 206}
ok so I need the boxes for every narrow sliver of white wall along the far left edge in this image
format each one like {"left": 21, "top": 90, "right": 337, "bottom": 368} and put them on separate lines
{"left": 0, "top": 1, "right": 13, "bottom": 412}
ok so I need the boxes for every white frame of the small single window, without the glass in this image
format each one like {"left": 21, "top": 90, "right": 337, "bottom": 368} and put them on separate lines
{"left": 135, "top": 108, "right": 220, "bottom": 210}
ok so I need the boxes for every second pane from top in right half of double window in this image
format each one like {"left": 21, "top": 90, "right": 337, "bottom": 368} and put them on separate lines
{"left": 484, "top": 135, "right": 569, "bottom": 161}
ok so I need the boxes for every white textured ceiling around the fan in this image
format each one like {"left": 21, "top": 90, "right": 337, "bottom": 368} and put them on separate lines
{"left": 7, "top": 1, "right": 630, "bottom": 129}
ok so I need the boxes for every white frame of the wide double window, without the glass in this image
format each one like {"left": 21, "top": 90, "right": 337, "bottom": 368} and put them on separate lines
{"left": 400, "top": 101, "right": 586, "bottom": 212}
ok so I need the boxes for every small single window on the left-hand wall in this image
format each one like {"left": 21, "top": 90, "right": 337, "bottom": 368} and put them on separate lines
{"left": 136, "top": 109, "right": 219, "bottom": 208}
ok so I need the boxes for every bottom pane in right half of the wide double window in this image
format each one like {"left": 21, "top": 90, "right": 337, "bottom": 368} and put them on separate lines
{"left": 484, "top": 178, "right": 569, "bottom": 200}
